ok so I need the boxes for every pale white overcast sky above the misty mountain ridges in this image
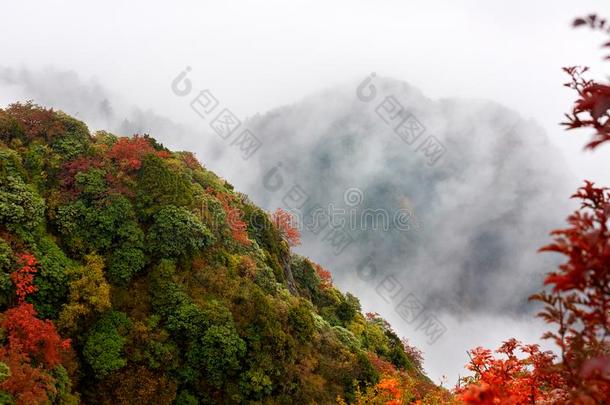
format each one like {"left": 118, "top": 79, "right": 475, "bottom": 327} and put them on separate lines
{"left": 0, "top": 0, "right": 610, "bottom": 384}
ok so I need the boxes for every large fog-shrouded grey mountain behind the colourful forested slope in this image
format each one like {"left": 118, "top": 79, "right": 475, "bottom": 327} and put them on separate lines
{"left": 236, "top": 76, "right": 570, "bottom": 312}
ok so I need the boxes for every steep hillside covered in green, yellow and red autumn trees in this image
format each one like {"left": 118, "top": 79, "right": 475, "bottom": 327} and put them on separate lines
{"left": 0, "top": 103, "right": 447, "bottom": 405}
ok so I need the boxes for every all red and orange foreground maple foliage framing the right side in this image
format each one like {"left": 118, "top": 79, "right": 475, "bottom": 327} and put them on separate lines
{"left": 457, "top": 15, "right": 610, "bottom": 404}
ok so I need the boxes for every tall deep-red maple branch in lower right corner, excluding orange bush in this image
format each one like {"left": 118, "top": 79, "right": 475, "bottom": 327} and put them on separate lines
{"left": 532, "top": 182, "right": 610, "bottom": 400}
